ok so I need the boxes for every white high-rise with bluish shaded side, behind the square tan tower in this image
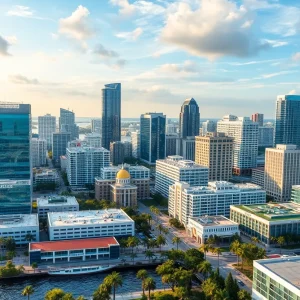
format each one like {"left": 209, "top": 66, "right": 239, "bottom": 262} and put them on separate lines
{"left": 217, "top": 115, "right": 258, "bottom": 175}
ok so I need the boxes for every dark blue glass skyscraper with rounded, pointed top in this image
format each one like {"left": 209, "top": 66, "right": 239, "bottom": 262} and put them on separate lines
{"left": 179, "top": 98, "right": 200, "bottom": 138}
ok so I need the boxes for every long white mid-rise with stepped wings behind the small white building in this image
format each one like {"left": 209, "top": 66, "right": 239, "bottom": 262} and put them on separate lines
{"left": 168, "top": 181, "right": 266, "bottom": 225}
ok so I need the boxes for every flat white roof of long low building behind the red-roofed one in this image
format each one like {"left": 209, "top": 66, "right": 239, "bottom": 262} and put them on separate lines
{"left": 48, "top": 209, "right": 133, "bottom": 227}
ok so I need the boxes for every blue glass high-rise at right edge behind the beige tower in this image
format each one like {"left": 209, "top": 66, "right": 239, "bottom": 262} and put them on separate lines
{"left": 274, "top": 95, "right": 300, "bottom": 147}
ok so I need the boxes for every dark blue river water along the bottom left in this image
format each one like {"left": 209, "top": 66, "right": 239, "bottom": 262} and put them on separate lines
{"left": 0, "top": 269, "right": 163, "bottom": 300}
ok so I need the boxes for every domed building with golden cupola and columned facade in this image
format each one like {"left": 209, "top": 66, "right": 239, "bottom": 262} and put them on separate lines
{"left": 111, "top": 167, "right": 137, "bottom": 207}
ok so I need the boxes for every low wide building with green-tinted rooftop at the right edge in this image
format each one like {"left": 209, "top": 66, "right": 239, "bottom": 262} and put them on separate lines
{"left": 230, "top": 202, "right": 300, "bottom": 245}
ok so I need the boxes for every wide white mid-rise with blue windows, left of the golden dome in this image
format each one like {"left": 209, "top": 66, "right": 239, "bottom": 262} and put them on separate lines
{"left": 66, "top": 147, "right": 110, "bottom": 187}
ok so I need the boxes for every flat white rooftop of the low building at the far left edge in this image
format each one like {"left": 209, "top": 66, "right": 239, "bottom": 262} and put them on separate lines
{"left": 0, "top": 214, "right": 39, "bottom": 229}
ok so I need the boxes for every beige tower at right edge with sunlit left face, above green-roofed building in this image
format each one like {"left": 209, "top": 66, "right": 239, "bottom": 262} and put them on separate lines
{"left": 264, "top": 145, "right": 300, "bottom": 201}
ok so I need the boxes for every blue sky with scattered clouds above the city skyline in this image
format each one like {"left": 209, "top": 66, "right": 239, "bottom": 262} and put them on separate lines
{"left": 0, "top": 0, "right": 300, "bottom": 118}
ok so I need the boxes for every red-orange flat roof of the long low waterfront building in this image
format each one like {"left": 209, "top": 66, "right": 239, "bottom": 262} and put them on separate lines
{"left": 29, "top": 237, "right": 119, "bottom": 252}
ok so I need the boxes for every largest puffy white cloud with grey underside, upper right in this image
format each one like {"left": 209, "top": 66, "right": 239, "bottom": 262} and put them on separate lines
{"left": 161, "top": 0, "right": 270, "bottom": 59}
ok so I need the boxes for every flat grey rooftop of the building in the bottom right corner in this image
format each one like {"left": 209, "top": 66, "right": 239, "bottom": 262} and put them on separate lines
{"left": 254, "top": 256, "right": 300, "bottom": 295}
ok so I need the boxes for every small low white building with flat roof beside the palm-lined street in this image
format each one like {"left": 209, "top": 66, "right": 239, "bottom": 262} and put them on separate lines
{"left": 186, "top": 216, "right": 240, "bottom": 244}
